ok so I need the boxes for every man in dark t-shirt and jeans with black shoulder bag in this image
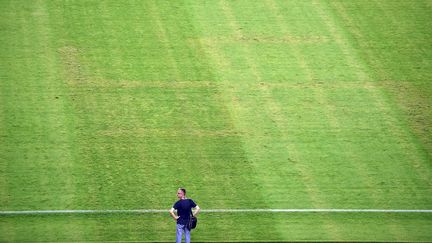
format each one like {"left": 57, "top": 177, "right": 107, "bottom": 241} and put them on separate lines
{"left": 170, "top": 188, "right": 200, "bottom": 243}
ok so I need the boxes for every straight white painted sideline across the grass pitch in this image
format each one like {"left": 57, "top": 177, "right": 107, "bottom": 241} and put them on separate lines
{"left": 0, "top": 208, "right": 432, "bottom": 215}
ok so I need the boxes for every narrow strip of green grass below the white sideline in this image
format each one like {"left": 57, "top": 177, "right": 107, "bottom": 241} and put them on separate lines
{"left": 1, "top": 213, "right": 430, "bottom": 242}
